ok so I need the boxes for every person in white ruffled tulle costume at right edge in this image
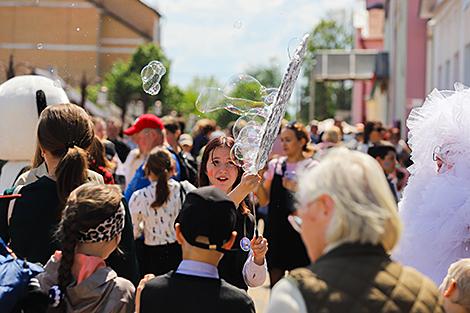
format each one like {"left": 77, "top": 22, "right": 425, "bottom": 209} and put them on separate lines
{"left": 393, "top": 84, "right": 470, "bottom": 285}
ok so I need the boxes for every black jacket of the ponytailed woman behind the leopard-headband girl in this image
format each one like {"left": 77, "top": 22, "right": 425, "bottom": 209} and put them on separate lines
{"left": 0, "top": 176, "right": 139, "bottom": 285}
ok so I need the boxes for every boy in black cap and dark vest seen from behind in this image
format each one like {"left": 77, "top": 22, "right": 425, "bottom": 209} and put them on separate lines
{"left": 140, "top": 187, "right": 255, "bottom": 313}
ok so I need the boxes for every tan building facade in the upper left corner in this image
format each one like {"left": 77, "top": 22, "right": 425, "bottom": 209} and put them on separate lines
{"left": 0, "top": 0, "right": 161, "bottom": 85}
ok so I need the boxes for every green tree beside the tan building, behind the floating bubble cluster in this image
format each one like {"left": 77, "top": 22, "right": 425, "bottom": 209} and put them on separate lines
{"left": 104, "top": 43, "right": 184, "bottom": 117}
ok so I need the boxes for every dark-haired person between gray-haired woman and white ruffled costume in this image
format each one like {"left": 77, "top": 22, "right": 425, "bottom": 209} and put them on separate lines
{"left": 367, "top": 143, "right": 398, "bottom": 203}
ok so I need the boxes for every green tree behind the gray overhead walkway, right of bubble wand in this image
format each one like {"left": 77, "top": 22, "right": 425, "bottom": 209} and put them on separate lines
{"left": 300, "top": 19, "right": 353, "bottom": 122}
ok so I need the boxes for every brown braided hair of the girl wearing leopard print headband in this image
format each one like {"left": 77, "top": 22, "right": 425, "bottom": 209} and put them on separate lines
{"left": 56, "top": 183, "right": 122, "bottom": 312}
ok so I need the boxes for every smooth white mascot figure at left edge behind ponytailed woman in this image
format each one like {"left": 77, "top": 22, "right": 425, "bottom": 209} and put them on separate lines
{"left": 0, "top": 75, "right": 69, "bottom": 194}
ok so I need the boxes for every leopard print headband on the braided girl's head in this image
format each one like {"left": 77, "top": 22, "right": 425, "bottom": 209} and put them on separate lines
{"left": 79, "top": 202, "right": 126, "bottom": 243}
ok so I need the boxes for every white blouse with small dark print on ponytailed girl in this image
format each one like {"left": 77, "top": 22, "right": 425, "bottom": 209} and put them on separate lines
{"left": 129, "top": 179, "right": 196, "bottom": 246}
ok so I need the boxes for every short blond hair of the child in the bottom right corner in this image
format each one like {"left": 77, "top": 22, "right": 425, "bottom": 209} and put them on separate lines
{"left": 439, "top": 259, "right": 470, "bottom": 311}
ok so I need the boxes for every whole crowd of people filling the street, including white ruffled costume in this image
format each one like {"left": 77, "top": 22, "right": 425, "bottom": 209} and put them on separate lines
{"left": 0, "top": 83, "right": 470, "bottom": 313}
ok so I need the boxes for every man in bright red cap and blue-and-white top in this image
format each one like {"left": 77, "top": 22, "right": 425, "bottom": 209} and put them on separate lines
{"left": 124, "top": 114, "right": 179, "bottom": 201}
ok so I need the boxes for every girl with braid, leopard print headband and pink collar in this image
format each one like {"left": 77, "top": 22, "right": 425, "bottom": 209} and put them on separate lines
{"left": 38, "top": 183, "right": 135, "bottom": 312}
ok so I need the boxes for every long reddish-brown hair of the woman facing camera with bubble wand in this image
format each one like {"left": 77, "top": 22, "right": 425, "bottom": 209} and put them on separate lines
{"left": 198, "top": 136, "right": 250, "bottom": 214}
